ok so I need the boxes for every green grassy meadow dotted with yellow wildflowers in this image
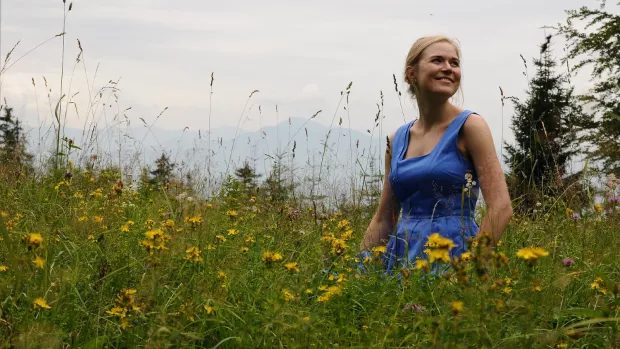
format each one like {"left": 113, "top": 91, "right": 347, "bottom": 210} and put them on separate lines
{"left": 0, "top": 163, "right": 620, "bottom": 348}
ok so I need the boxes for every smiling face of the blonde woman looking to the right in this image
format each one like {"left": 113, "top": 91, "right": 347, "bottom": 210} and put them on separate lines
{"left": 407, "top": 42, "right": 461, "bottom": 99}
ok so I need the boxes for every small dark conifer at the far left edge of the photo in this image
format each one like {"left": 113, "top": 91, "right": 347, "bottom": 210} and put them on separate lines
{"left": 0, "top": 107, "right": 33, "bottom": 170}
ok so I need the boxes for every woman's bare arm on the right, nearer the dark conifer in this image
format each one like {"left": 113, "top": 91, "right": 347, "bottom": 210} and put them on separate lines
{"left": 463, "top": 114, "right": 513, "bottom": 246}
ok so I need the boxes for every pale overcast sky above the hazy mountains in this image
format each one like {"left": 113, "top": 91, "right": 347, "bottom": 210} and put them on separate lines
{"left": 0, "top": 0, "right": 618, "bottom": 152}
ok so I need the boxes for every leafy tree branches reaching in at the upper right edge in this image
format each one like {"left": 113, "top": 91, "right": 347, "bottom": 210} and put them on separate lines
{"left": 557, "top": 2, "right": 620, "bottom": 176}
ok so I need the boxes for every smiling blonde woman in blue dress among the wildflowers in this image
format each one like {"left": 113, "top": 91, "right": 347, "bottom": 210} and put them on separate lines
{"left": 360, "top": 36, "right": 513, "bottom": 272}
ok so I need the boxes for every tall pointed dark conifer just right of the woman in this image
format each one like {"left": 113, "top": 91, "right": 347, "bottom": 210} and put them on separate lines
{"left": 505, "top": 36, "right": 588, "bottom": 207}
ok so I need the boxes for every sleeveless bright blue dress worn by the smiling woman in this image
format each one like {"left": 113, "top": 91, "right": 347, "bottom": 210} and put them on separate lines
{"left": 368, "top": 110, "right": 480, "bottom": 272}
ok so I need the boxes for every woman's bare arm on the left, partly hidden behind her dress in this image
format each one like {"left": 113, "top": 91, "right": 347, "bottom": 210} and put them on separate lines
{"left": 360, "top": 134, "right": 400, "bottom": 251}
